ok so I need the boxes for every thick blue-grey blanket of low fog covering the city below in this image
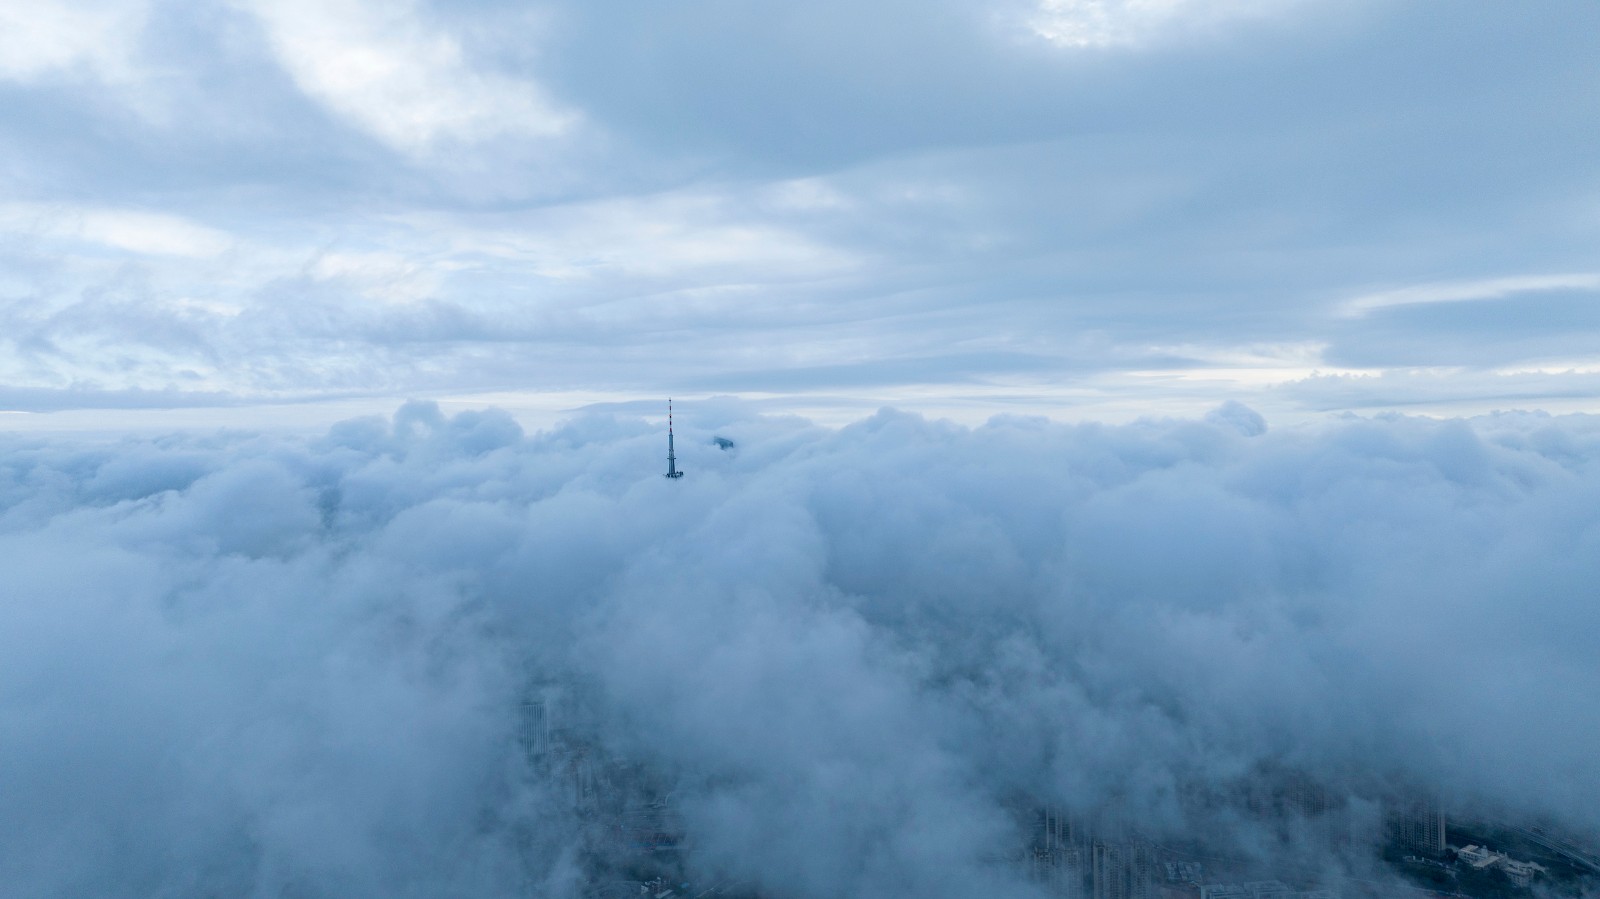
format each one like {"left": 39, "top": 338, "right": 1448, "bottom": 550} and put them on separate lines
{"left": 0, "top": 400, "right": 1600, "bottom": 897}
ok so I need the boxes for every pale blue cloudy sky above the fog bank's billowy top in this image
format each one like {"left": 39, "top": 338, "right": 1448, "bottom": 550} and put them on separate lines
{"left": 0, "top": 0, "right": 1600, "bottom": 430}
